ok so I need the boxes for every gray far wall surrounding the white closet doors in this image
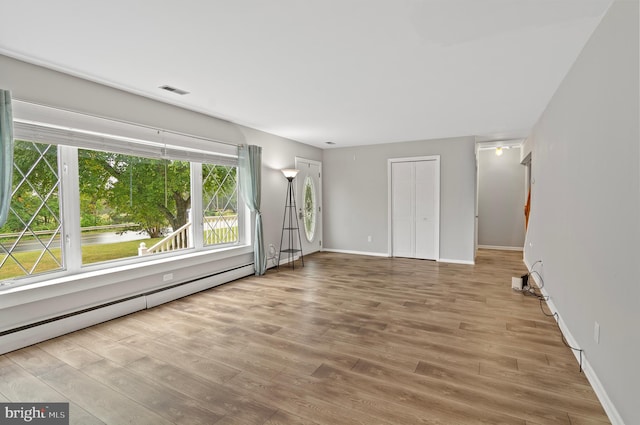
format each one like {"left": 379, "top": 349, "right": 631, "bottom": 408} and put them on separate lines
{"left": 323, "top": 137, "right": 476, "bottom": 262}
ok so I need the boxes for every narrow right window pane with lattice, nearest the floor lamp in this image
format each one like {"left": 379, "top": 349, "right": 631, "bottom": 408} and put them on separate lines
{"left": 202, "top": 164, "right": 238, "bottom": 245}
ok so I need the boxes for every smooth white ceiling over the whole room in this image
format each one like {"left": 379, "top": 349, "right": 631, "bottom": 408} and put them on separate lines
{"left": 0, "top": 0, "right": 612, "bottom": 148}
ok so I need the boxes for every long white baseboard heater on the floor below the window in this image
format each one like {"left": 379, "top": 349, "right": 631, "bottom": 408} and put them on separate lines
{"left": 0, "top": 264, "right": 254, "bottom": 355}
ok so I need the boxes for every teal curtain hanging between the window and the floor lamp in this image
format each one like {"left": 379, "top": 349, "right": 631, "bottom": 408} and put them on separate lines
{"left": 238, "top": 145, "right": 267, "bottom": 276}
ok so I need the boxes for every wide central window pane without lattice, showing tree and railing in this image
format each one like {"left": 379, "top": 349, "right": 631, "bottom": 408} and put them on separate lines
{"left": 78, "top": 150, "right": 192, "bottom": 264}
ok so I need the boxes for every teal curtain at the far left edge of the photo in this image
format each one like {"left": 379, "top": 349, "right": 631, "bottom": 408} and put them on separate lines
{"left": 0, "top": 90, "right": 13, "bottom": 226}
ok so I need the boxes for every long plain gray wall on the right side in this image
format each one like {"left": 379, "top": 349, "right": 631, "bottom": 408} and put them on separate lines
{"left": 525, "top": 1, "right": 640, "bottom": 424}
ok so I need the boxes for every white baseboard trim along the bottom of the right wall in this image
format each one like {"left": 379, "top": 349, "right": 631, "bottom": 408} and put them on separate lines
{"left": 523, "top": 260, "right": 625, "bottom": 425}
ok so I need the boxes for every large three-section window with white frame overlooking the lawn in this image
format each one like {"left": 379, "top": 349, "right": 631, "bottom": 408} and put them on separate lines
{"left": 0, "top": 111, "right": 244, "bottom": 285}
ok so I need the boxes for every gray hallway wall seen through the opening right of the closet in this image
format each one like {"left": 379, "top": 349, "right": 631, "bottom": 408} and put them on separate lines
{"left": 478, "top": 148, "right": 525, "bottom": 248}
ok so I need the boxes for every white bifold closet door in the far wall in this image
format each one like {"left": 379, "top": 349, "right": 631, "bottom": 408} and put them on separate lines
{"left": 391, "top": 160, "right": 440, "bottom": 260}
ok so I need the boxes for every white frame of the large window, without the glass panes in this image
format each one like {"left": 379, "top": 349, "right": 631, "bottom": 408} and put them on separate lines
{"left": 0, "top": 102, "right": 252, "bottom": 293}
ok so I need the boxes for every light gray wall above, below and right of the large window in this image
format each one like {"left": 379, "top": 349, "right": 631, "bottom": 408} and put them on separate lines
{"left": 0, "top": 55, "right": 322, "bottom": 340}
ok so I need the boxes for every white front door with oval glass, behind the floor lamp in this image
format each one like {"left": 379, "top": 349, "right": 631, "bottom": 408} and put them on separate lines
{"left": 296, "top": 158, "right": 322, "bottom": 255}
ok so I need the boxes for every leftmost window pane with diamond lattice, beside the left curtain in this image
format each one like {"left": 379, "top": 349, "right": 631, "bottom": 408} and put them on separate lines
{"left": 0, "top": 140, "right": 63, "bottom": 280}
